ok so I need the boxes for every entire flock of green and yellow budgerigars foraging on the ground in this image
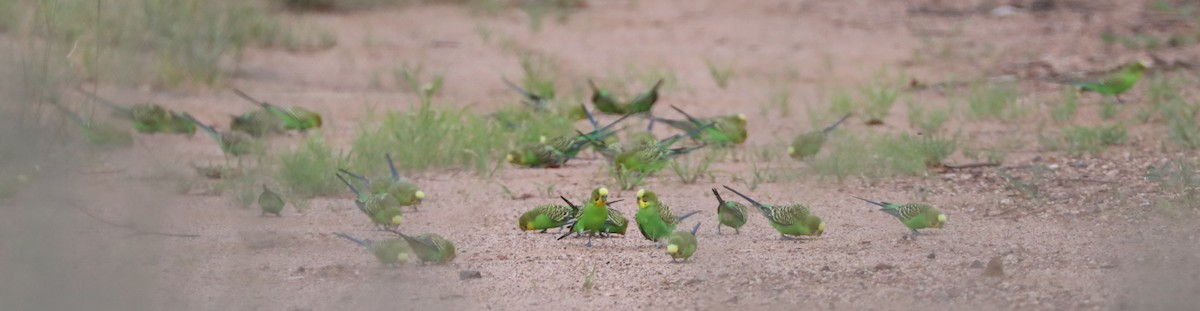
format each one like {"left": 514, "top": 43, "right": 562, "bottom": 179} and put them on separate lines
{"left": 52, "top": 62, "right": 1146, "bottom": 265}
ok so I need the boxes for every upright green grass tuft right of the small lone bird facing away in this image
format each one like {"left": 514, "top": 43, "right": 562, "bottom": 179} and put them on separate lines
{"left": 275, "top": 131, "right": 345, "bottom": 199}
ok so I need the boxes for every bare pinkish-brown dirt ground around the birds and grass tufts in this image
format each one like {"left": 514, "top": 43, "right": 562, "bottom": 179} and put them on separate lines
{"left": 0, "top": 0, "right": 1200, "bottom": 310}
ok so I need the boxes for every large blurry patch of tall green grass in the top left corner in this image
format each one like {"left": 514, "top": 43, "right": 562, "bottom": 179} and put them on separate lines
{"left": 9, "top": 0, "right": 336, "bottom": 88}
